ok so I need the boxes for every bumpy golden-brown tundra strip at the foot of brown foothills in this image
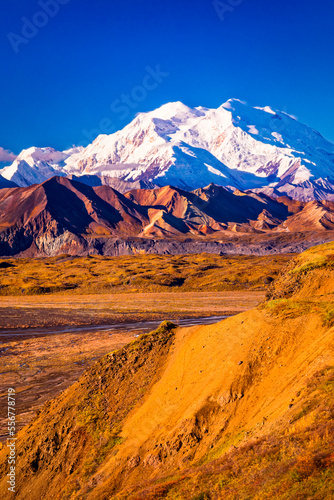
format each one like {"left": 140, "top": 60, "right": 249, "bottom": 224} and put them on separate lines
{"left": 0, "top": 254, "right": 291, "bottom": 296}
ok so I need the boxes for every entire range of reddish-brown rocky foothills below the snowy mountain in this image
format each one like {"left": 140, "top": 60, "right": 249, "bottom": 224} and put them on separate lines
{"left": 0, "top": 177, "right": 334, "bottom": 256}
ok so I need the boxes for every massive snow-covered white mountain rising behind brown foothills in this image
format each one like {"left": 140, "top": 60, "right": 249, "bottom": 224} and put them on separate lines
{"left": 0, "top": 99, "right": 334, "bottom": 201}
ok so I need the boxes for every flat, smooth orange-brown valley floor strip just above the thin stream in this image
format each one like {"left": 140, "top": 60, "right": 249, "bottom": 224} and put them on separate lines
{"left": 0, "top": 291, "right": 264, "bottom": 330}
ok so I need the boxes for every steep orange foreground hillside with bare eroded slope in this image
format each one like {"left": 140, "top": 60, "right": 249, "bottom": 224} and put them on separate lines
{"left": 0, "top": 243, "right": 334, "bottom": 500}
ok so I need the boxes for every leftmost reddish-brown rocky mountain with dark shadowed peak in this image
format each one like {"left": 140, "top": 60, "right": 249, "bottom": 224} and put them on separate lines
{"left": 0, "top": 177, "right": 149, "bottom": 255}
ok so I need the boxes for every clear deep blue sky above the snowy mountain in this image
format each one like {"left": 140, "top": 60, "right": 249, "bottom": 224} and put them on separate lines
{"left": 0, "top": 0, "right": 334, "bottom": 153}
